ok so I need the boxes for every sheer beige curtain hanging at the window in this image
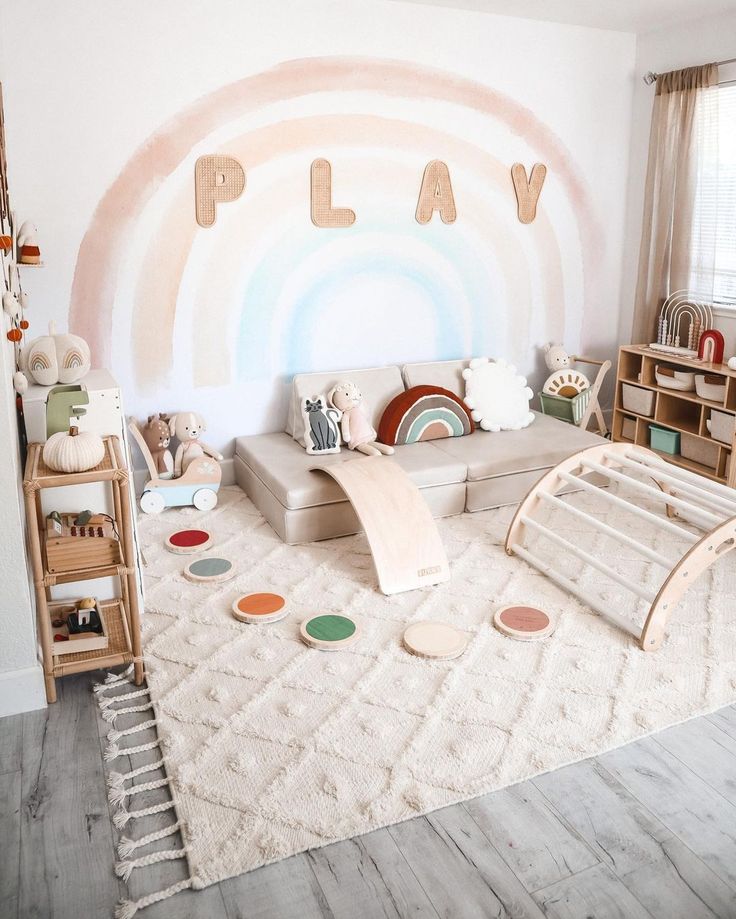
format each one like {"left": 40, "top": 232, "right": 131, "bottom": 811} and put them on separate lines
{"left": 631, "top": 64, "right": 718, "bottom": 344}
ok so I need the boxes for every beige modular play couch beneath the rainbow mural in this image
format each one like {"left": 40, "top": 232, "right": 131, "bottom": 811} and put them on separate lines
{"left": 234, "top": 361, "right": 601, "bottom": 544}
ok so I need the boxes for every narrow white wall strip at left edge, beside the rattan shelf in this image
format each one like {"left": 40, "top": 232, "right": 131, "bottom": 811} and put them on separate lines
{"left": 0, "top": 3, "right": 46, "bottom": 717}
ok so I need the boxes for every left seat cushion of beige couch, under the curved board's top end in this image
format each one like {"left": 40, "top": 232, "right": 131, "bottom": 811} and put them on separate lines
{"left": 235, "top": 432, "right": 467, "bottom": 509}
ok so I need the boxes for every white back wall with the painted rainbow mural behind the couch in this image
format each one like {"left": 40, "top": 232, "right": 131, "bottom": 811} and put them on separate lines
{"left": 0, "top": 0, "right": 634, "bottom": 458}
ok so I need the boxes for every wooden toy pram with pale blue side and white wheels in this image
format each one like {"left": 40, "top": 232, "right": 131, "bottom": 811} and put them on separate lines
{"left": 128, "top": 416, "right": 222, "bottom": 514}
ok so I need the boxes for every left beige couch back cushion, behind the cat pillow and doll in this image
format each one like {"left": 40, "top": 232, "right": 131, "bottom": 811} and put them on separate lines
{"left": 286, "top": 366, "right": 404, "bottom": 447}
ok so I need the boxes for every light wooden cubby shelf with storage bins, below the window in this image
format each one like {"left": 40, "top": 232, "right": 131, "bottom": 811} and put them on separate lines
{"left": 613, "top": 345, "right": 736, "bottom": 488}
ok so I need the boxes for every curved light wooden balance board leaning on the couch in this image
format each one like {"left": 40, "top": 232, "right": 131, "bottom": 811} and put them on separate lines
{"left": 311, "top": 456, "right": 450, "bottom": 594}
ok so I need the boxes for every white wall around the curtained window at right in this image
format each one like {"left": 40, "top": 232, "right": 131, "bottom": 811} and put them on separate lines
{"left": 619, "top": 11, "right": 736, "bottom": 356}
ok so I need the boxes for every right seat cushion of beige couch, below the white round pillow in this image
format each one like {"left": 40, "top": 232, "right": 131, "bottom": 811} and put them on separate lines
{"left": 433, "top": 412, "right": 604, "bottom": 482}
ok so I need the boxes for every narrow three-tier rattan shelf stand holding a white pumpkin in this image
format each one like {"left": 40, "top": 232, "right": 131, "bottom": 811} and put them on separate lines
{"left": 23, "top": 437, "right": 143, "bottom": 702}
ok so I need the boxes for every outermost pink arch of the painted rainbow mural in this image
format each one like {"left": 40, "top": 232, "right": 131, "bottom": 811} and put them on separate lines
{"left": 69, "top": 50, "right": 602, "bottom": 365}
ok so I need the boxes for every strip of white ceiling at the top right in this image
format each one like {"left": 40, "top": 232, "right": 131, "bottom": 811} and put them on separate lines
{"left": 394, "top": 0, "right": 736, "bottom": 32}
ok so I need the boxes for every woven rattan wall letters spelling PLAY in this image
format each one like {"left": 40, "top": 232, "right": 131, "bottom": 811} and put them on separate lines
{"left": 194, "top": 155, "right": 547, "bottom": 228}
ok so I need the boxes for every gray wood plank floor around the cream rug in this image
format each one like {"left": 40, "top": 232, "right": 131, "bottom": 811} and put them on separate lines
{"left": 0, "top": 674, "right": 736, "bottom": 919}
